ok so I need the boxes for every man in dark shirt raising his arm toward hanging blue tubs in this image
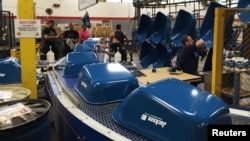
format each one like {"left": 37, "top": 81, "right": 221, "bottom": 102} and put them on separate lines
{"left": 177, "top": 35, "right": 205, "bottom": 74}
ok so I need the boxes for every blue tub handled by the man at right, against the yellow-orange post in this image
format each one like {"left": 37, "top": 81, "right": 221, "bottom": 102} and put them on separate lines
{"left": 198, "top": 2, "right": 226, "bottom": 48}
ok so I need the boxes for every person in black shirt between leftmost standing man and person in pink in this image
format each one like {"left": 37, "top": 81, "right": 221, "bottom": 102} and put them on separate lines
{"left": 63, "top": 23, "right": 79, "bottom": 56}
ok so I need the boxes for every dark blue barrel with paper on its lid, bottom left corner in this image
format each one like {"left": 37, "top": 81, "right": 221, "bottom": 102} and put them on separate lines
{"left": 0, "top": 99, "right": 50, "bottom": 141}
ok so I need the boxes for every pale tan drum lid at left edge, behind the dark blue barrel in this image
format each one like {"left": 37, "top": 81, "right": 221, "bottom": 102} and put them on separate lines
{"left": 0, "top": 86, "right": 31, "bottom": 103}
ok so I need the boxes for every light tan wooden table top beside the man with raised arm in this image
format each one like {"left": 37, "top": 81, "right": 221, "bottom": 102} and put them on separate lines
{"left": 137, "top": 67, "right": 202, "bottom": 85}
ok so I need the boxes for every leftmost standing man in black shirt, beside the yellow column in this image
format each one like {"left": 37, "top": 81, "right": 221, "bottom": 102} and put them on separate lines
{"left": 42, "top": 20, "right": 62, "bottom": 60}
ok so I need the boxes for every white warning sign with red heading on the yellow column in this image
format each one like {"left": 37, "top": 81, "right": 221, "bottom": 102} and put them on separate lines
{"left": 15, "top": 19, "right": 41, "bottom": 38}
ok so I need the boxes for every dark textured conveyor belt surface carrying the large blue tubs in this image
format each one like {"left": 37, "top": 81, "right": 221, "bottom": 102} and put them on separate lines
{"left": 53, "top": 70, "right": 150, "bottom": 141}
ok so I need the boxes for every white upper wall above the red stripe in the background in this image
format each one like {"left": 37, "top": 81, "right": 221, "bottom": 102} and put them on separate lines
{"left": 2, "top": 0, "right": 205, "bottom": 18}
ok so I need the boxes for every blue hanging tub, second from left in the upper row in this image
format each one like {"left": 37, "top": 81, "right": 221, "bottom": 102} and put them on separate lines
{"left": 151, "top": 12, "right": 171, "bottom": 44}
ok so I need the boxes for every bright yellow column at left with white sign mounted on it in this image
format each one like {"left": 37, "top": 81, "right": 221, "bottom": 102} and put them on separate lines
{"left": 17, "top": 0, "right": 37, "bottom": 99}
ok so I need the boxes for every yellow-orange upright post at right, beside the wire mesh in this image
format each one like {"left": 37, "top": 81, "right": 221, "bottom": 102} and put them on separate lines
{"left": 211, "top": 8, "right": 225, "bottom": 97}
